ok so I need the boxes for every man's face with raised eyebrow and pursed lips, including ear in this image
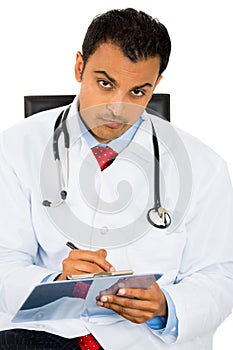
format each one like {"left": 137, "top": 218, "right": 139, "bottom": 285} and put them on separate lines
{"left": 75, "top": 43, "right": 161, "bottom": 143}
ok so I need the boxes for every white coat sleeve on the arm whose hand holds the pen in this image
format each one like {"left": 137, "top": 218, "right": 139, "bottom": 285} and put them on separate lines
{"left": 0, "top": 135, "right": 54, "bottom": 313}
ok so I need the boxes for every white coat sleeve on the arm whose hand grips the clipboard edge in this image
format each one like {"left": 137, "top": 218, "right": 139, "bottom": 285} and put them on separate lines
{"left": 164, "top": 160, "right": 233, "bottom": 342}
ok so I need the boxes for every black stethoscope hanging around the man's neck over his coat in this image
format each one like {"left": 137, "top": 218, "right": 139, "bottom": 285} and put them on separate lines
{"left": 42, "top": 106, "right": 171, "bottom": 229}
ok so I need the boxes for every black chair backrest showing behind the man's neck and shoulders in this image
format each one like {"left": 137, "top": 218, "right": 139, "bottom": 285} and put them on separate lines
{"left": 24, "top": 94, "right": 170, "bottom": 121}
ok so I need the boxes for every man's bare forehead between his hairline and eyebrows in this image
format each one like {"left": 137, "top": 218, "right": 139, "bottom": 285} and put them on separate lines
{"left": 85, "top": 43, "right": 160, "bottom": 83}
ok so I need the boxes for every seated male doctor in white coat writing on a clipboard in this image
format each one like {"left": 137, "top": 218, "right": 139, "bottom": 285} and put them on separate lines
{"left": 0, "top": 9, "right": 233, "bottom": 350}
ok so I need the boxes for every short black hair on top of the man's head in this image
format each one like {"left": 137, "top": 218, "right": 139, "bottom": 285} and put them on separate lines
{"left": 82, "top": 8, "right": 171, "bottom": 74}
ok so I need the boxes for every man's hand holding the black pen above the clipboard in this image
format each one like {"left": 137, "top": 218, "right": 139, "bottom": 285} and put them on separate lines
{"left": 56, "top": 249, "right": 115, "bottom": 281}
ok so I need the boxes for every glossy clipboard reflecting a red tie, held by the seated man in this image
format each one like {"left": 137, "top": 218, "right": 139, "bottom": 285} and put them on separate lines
{"left": 12, "top": 270, "right": 162, "bottom": 323}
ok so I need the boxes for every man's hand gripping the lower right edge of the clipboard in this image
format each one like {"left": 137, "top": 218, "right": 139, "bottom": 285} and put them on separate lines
{"left": 96, "top": 282, "right": 167, "bottom": 323}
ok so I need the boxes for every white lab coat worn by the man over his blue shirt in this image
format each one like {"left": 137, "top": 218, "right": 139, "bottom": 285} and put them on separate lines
{"left": 0, "top": 97, "right": 233, "bottom": 350}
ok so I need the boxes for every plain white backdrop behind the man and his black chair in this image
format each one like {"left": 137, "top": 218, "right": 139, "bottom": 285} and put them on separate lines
{"left": 0, "top": 0, "right": 233, "bottom": 350}
